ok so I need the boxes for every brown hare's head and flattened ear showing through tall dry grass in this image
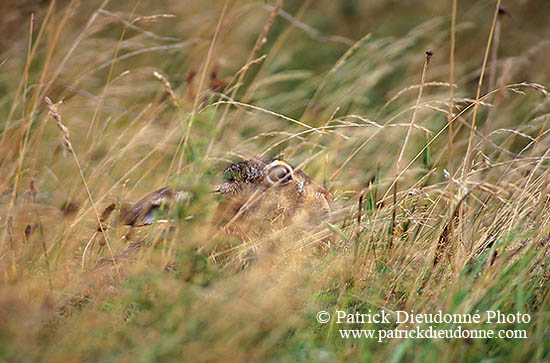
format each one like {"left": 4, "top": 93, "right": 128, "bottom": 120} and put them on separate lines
{"left": 121, "top": 159, "right": 333, "bottom": 239}
